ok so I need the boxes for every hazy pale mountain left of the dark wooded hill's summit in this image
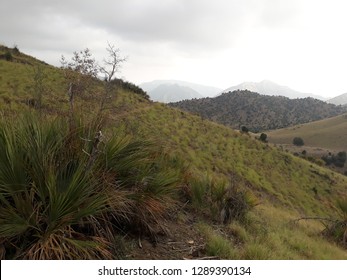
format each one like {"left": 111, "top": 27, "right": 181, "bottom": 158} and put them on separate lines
{"left": 140, "top": 80, "right": 222, "bottom": 103}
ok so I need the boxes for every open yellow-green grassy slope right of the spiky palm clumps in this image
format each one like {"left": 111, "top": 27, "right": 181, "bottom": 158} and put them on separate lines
{"left": 115, "top": 101, "right": 346, "bottom": 259}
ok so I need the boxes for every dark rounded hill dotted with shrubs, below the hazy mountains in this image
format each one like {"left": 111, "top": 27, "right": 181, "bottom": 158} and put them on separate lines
{"left": 170, "top": 90, "right": 345, "bottom": 132}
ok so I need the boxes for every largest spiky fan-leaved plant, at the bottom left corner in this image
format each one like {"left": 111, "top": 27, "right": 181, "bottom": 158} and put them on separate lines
{"left": 0, "top": 114, "right": 111, "bottom": 259}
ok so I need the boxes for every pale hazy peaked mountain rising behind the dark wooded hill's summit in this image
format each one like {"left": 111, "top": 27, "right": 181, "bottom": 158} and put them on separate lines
{"left": 223, "top": 80, "right": 325, "bottom": 100}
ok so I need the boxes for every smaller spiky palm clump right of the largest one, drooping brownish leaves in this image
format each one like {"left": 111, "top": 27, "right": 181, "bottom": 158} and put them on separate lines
{"left": 98, "top": 137, "right": 181, "bottom": 238}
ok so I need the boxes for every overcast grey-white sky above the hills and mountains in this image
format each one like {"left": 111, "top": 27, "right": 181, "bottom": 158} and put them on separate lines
{"left": 0, "top": 0, "right": 347, "bottom": 97}
